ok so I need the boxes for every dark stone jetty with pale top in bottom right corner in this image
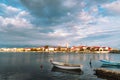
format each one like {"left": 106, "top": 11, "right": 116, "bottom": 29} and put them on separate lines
{"left": 94, "top": 68, "right": 120, "bottom": 80}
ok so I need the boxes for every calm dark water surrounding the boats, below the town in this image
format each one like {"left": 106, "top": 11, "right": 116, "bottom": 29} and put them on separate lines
{"left": 0, "top": 52, "right": 120, "bottom": 80}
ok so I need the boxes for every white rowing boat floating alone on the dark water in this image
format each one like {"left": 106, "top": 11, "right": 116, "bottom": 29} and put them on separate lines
{"left": 51, "top": 61, "right": 82, "bottom": 70}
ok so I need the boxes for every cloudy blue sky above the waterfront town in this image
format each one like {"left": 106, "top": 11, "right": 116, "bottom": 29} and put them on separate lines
{"left": 0, "top": 0, "right": 120, "bottom": 49}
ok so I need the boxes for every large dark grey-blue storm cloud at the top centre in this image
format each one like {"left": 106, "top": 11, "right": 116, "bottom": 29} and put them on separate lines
{"left": 21, "top": 0, "right": 81, "bottom": 24}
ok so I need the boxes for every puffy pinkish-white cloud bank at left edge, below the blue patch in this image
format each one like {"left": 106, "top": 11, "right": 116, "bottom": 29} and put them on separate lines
{"left": 0, "top": 16, "right": 32, "bottom": 29}
